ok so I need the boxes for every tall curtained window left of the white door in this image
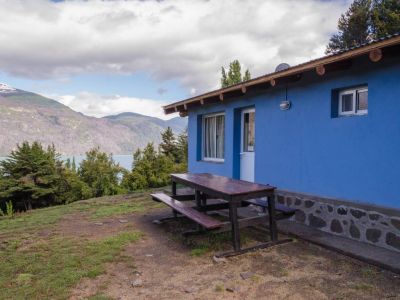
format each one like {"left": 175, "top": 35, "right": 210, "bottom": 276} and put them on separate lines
{"left": 203, "top": 113, "right": 225, "bottom": 161}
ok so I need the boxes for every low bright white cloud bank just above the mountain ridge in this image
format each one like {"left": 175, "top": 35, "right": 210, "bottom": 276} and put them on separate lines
{"left": 46, "top": 92, "right": 171, "bottom": 119}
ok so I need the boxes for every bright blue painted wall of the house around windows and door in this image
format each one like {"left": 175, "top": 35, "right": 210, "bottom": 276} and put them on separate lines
{"left": 188, "top": 58, "right": 400, "bottom": 208}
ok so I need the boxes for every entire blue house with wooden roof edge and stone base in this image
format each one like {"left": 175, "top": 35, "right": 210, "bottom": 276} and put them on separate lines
{"left": 164, "top": 35, "right": 400, "bottom": 251}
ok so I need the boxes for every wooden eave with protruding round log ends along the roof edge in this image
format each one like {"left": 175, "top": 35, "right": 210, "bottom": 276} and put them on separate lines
{"left": 163, "top": 35, "right": 400, "bottom": 116}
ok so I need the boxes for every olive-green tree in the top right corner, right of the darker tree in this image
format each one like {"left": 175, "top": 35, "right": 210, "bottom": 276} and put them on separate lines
{"left": 371, "top": 0, "right": 400, "bottom": 38}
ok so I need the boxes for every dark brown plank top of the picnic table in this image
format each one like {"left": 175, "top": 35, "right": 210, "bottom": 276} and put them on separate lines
{"left": 171, "top": 173, "right": 276, "bottom": 198}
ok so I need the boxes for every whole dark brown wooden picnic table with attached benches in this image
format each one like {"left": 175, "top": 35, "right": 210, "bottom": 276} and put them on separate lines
{"left": 152, "top": 173, "right": 290, "bottom": 257}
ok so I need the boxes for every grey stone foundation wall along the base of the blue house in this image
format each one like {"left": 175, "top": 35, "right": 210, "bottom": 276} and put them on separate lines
{"left": 277, "top": 191, "right": 400, "bottom": 252}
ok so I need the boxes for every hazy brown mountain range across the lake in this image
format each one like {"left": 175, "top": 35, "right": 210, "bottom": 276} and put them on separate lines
{"left": 0, "top": 84, "right": 187, "bottom": 156}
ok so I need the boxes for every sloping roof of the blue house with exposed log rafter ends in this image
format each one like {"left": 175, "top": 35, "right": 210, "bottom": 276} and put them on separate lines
{"left": 163, "top": 33, "right": 400, "bottom": 116}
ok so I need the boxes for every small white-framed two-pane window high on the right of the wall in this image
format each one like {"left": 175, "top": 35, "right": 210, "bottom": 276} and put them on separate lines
{"left": 339, "top": 87, "right": 368, "bottom": 116}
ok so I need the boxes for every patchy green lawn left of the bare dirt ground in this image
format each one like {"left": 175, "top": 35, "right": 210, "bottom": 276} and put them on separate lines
{"left": 0, "top": 193, "right": 162, "bottom": 299}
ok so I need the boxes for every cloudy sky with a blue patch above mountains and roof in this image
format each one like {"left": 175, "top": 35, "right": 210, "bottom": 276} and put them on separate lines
{"left": 0, "top": 0, "right": 350, "bottom": 119}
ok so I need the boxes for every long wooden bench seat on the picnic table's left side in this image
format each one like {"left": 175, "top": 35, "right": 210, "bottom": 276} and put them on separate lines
{"left": 151, "top": 193, "right": 223, "bottom": 230}
